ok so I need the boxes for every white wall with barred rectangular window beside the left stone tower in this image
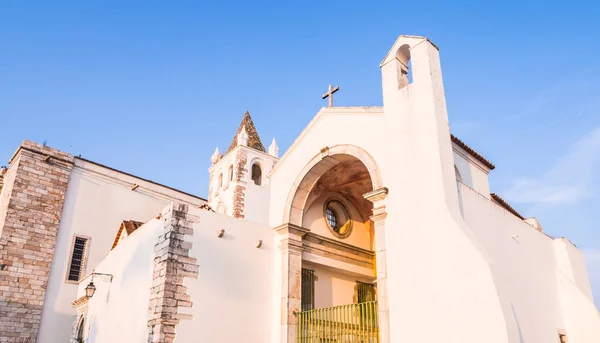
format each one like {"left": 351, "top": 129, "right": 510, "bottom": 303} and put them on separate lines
{"left": 38, "top": 158, "right": 204, "bottom": 343}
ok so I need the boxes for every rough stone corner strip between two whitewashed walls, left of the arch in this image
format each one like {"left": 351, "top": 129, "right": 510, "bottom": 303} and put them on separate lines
{"left": 148, "top": 204, "right": 199, "bottom": 343}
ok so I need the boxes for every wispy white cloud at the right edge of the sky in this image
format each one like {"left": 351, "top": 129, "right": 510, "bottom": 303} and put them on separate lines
{"left": 506, "top": 128, "right": 600, "bottom": 205}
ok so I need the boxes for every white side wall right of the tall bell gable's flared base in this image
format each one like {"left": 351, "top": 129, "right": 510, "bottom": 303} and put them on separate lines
{"left": 459, "top": 184, "right": 600, "bottom": 343}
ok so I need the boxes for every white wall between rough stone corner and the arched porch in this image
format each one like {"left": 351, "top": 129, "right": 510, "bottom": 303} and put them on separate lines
{"left": 176, "top": 209, "right": 281, "bottom": 343}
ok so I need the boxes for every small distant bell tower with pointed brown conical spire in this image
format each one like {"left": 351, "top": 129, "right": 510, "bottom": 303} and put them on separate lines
{"left": 208, "top": 111, "right": 279, "bottom": 224}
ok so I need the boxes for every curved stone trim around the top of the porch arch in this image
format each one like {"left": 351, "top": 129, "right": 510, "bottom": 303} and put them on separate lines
{"left": 283, "top": 144, "right": 383, "bottom": 226}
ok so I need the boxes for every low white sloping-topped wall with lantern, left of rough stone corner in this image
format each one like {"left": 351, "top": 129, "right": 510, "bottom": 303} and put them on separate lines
{"left": 75, "top": 219, "right": 164, "bottom": 343}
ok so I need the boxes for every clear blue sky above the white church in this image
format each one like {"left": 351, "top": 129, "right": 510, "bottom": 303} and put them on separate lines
{"left": 0, "top": 1, "right": 600, "bottom": 303}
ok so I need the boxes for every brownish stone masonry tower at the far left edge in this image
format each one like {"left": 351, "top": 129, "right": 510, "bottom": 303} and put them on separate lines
{"left": 0, "top": 141, "right": 73, "bottom": 343}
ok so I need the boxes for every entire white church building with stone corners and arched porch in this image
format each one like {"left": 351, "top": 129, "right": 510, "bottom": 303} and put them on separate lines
{"left": 0, "top": 36, "right": 600, "bottom": 343}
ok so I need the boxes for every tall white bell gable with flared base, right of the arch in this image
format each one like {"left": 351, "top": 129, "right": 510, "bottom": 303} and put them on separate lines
{"left": 378, "top": 36, "right": 508, "bottom": 343}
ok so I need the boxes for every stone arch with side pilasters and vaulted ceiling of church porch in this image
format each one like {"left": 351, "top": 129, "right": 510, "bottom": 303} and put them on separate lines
{"left": 276, "top": 145, "right": 389, "bottom": 343}
